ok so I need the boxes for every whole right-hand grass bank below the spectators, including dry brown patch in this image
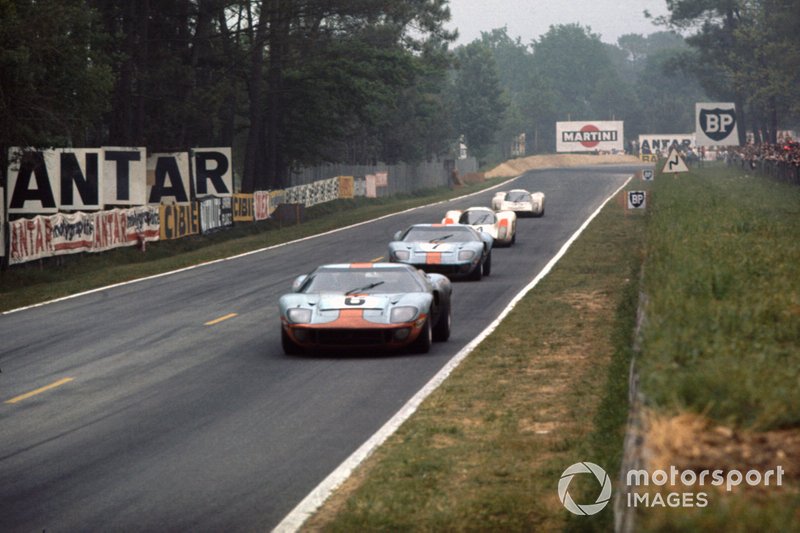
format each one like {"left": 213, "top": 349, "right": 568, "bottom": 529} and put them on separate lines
{"left": 637, "top": 166, "right": 800, "bottom": 531}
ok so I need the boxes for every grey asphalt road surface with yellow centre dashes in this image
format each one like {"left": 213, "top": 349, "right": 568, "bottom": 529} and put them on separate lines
{"left": 0, "top": 167, "right": 635, "bottom": 532}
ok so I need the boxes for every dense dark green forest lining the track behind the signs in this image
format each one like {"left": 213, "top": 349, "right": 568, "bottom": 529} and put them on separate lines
{"left": 0, "top": 0, "right": 800, "bottom": 191}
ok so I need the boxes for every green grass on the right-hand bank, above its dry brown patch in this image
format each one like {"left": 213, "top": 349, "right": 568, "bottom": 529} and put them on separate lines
{"left": 640, "top": 166, "right": 800, "bottom": 429}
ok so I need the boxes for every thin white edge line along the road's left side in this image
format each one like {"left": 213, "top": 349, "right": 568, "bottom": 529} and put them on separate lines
{"left": 0, "top": 173, "right": 525, "bottom": 316}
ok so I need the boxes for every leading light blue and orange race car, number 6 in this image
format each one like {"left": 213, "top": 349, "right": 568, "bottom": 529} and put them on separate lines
{"left": 279, "top": 263, "right": 452, "bottom": 355}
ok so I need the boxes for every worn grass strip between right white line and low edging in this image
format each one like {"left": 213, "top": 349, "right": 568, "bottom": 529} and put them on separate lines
{"left": 304, "top": 182, "right": 644, "bottom": 531}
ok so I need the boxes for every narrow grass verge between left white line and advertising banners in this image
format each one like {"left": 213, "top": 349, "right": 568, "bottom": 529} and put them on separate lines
{"left": 0, "top": 179, "right": 505, "bottom": 311}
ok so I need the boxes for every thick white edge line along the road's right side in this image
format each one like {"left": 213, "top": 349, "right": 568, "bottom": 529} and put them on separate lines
{"left": 272, "top": 176, "right": 633, "bottom": 533}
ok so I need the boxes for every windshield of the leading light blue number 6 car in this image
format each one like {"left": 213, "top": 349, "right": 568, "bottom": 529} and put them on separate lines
{"left": 302, "top": 268, "right": 423, "bottom": 295}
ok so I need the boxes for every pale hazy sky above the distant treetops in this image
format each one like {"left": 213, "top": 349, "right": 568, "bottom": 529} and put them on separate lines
{"left": 447, "top": 0, "right": 667, "bottom": 45}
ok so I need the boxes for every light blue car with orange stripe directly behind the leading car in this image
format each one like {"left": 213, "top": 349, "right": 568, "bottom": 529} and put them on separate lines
{"left": 389, "top": 224, "right": 494, "bottom": 280}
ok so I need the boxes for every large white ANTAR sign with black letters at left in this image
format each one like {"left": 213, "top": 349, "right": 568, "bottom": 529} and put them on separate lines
{"left": 6, "top": 147, "right": 233, "bottom": 214}
